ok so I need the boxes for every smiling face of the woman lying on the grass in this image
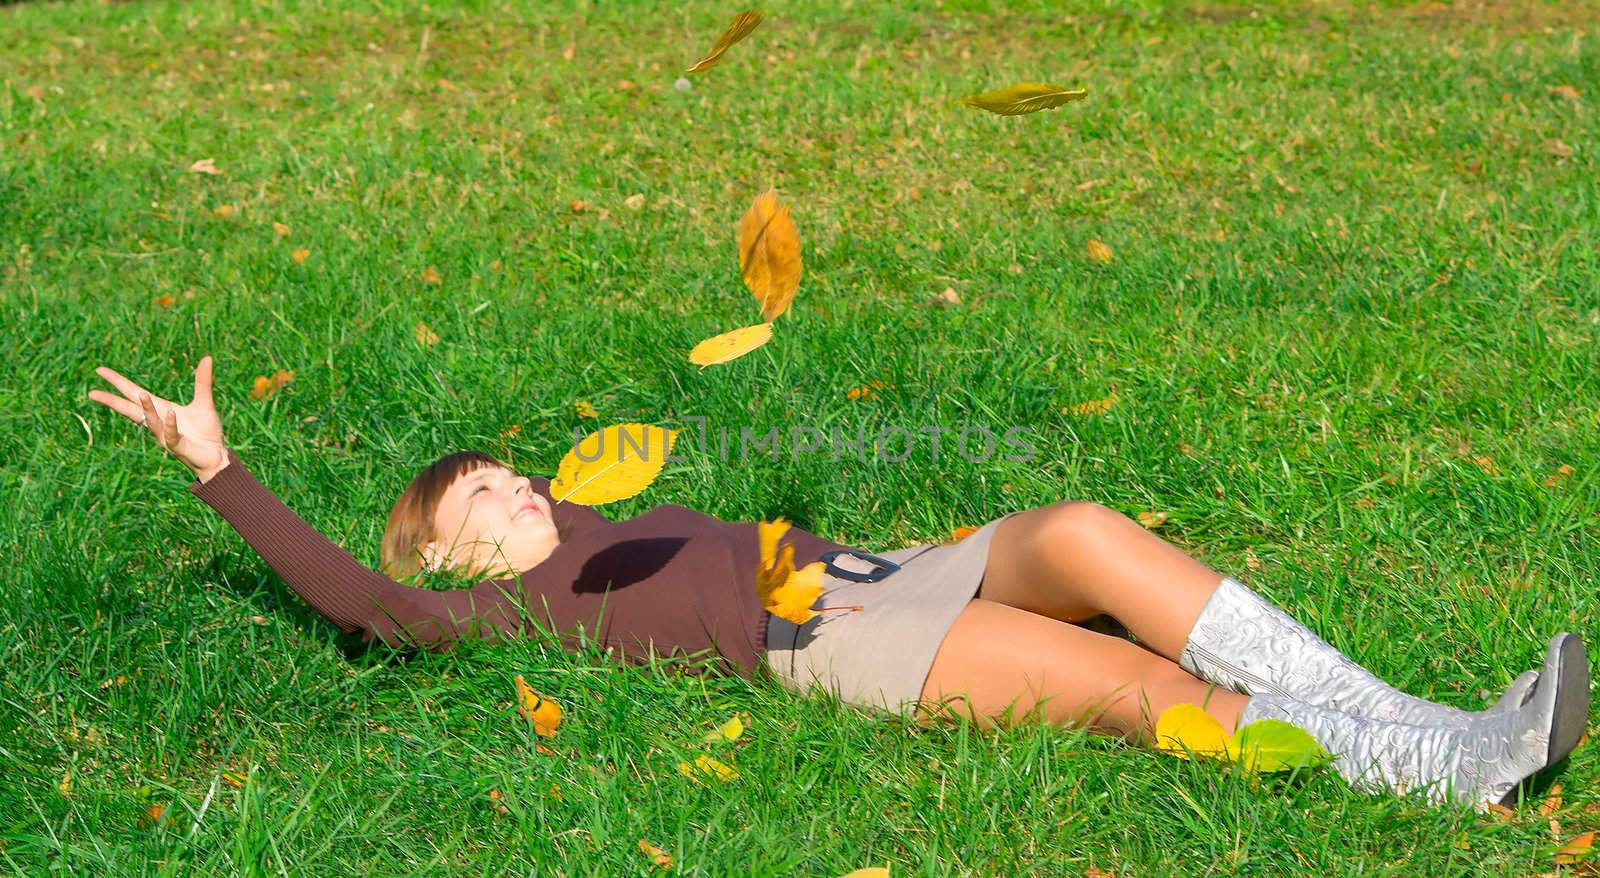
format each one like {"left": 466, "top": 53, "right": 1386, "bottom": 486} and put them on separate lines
{"left": 422, "top": 467, "right": 560, "bottom": 576}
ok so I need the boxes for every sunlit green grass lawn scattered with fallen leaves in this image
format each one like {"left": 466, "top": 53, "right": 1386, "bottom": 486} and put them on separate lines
{"left": 0, "top": 0, "right": 1600, "bottom": 878}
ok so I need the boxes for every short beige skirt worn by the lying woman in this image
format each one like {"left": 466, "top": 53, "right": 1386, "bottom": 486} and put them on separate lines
{"left": 766, "top": 510, "right": 1022, "bottom": 713}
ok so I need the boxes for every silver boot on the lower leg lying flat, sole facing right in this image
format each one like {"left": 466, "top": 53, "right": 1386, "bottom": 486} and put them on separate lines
{"left": 1238, "top": 635, "right": 1589, "bottom": 811}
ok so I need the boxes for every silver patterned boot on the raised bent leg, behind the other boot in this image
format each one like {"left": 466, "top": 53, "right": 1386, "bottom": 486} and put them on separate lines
{"left": 1178, "top": 577, "right": 1539, "bottom": 729}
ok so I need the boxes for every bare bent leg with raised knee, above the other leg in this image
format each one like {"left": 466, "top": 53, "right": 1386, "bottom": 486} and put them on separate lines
{"left": 979, "top": 501, "right": 1222, "bottom": 660}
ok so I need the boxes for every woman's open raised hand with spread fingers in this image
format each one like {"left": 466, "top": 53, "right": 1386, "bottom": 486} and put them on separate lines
{"left": 90, "top": 355, "right": 227, "bottom": 481}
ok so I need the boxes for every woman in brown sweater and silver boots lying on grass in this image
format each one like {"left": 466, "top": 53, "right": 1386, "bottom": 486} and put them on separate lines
{"left": 90, "top": 357, "right": 1589, "bottom": 808}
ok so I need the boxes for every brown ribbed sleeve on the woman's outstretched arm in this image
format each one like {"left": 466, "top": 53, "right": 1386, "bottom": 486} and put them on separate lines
{"left": 189, "top": 448, "right": 524, "bottom": 648}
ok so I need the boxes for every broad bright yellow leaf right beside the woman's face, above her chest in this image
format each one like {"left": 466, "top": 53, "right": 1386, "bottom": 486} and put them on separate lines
{"left": 550, "top": 424, "right": 678, "bottom": 505}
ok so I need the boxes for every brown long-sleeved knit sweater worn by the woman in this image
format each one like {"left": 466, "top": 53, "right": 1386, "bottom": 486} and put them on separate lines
{"left": 189, "top": 449, "right": 850, "bottom": 675}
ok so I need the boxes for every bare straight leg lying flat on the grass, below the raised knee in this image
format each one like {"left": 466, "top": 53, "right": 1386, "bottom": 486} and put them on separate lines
{"left": 922, "top": 598, "right": 1250, "bottom": 742}
